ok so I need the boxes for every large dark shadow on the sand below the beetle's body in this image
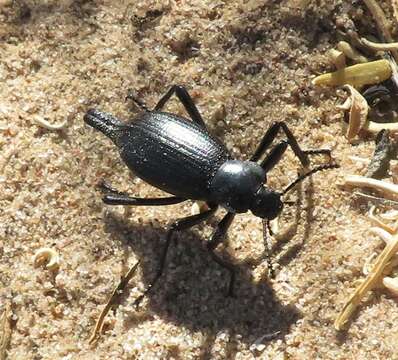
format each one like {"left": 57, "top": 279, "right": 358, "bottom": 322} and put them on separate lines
{"left": 105, "top": 212, "right": 300, "bottom": 350}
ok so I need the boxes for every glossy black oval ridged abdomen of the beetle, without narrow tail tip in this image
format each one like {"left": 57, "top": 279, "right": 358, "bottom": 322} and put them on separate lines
{"left": 118, "top": 112, "right": 230, "bottom": 199}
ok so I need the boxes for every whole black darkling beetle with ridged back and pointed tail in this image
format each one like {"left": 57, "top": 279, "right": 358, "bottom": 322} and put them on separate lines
{"left": 84, "top": 85, "right": 337, "bottom": 305}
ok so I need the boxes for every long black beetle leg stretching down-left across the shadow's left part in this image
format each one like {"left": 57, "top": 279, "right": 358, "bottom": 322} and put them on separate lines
{"left": 134, "top": 206, "right": 217, "bottom": 307}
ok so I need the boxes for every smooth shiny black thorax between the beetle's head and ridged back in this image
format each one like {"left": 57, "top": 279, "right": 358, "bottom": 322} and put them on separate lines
{"left": 210, "top": 160, "right": 266, "bottom": 213}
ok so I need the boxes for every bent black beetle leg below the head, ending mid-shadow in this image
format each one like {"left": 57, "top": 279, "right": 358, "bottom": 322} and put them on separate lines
{"left": 207, "top": 213, "right": 235, "bottom": 296}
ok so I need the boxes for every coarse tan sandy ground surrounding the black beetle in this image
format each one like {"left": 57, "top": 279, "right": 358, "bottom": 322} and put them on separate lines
{"left": 0, "top": 0, "right": 398, "bottom": 359}
